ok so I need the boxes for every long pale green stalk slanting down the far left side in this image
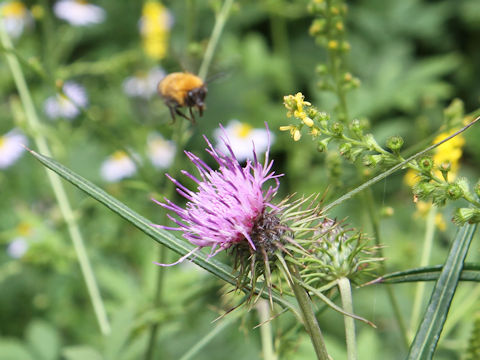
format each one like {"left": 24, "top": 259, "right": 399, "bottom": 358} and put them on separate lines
{"left": 0, "top": 18, "right": 110, "bottom": 335}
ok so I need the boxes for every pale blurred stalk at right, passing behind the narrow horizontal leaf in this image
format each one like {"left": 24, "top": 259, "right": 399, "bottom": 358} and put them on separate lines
{"left": 408, "top": 206, "right": 437, "bottom": 342}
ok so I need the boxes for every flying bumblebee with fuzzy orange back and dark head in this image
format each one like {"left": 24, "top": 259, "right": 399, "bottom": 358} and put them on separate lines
{"left": 158, "top": 72, "right": 207, "bottom": 124}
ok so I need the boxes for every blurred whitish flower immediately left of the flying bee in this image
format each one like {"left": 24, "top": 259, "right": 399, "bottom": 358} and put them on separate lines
{"left": 123, "top": 67, "right": 166, "bottom": 99}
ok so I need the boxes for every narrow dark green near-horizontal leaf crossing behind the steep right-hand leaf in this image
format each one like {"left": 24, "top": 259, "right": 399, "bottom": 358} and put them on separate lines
{"left": 365, "top": 264, "right": 480, "bottom": 285}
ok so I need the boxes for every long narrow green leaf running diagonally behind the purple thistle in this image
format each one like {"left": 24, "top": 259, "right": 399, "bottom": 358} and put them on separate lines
{"left": 29, "top": 150, "right": 294, "bottom": 310}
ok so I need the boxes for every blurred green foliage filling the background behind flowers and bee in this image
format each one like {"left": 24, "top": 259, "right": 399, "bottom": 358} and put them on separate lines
{"left": 0, "top": 0, "right": 480, "bottom": 360}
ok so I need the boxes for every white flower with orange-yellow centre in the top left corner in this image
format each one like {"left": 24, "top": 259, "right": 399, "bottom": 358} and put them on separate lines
{"left": 0, "top": 1, "right": 33, "bottom": 38}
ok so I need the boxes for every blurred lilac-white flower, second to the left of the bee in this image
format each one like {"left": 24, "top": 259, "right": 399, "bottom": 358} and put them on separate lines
{"left": 44, "top": 81, "right": 88, "bottom": 119}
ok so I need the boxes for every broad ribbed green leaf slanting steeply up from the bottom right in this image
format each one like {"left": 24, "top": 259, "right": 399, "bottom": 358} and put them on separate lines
{"left": 407, "top": 225, "right": 477, "bottom": 360}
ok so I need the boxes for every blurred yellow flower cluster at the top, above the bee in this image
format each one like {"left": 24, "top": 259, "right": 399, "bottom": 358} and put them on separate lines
{"left": 140, "top": 1, "right": 170, "bottom": 60}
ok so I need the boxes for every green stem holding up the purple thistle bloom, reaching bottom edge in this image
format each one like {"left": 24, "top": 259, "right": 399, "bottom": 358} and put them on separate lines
{"left": 289, "top": 264, "right": 329, "bottom": 360}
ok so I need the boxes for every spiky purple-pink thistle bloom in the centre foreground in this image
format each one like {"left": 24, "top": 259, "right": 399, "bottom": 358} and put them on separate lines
{"left": 154, "top": 124, "right": 282, "bottom": 266}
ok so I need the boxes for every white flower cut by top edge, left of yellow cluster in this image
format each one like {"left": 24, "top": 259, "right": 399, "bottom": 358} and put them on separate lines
{"left": 53, "top": 0, "right": 105, "bottom": 26}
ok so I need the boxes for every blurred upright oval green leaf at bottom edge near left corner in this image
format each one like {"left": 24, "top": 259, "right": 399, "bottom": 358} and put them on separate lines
{"left": 26, "top": 320, "right": 60, "bottom": 360}
